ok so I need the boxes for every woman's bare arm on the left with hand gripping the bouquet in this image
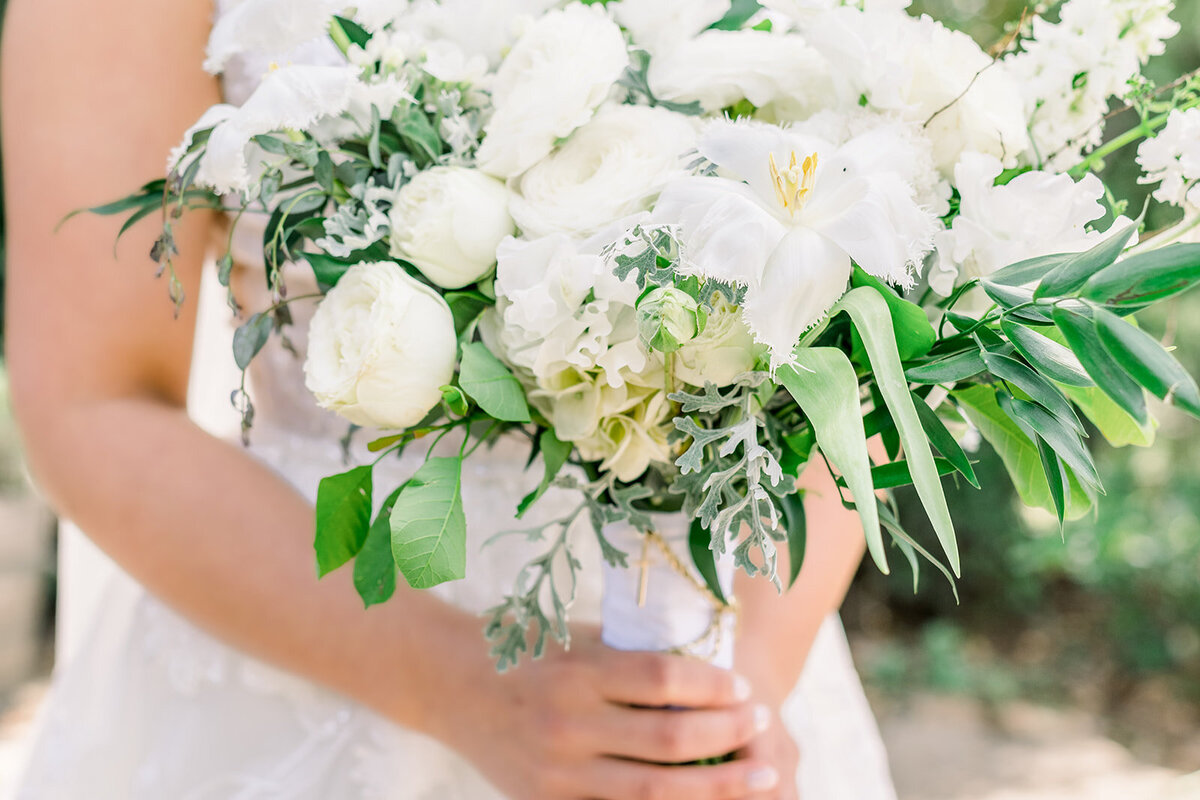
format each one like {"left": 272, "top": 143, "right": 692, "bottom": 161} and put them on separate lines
{"left": 0, "top": 0, "right": 778, "bottom": 800}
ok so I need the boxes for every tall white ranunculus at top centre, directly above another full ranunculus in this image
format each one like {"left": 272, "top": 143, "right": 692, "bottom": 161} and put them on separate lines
{"left": 478, "top": 4, "right": 629, "bottom": 178}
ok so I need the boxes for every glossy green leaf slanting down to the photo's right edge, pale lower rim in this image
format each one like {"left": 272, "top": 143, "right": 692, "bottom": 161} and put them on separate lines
{"left": 1093, "top": 308, "right": 1200, "bottom": 417}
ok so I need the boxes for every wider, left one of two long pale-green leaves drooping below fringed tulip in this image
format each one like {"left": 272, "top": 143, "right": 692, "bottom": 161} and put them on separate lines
{"left": 775, "top": 348, "right": 889, "bottom": 575}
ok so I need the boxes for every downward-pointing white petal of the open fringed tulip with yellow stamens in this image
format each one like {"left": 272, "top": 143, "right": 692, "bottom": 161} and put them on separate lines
{"left": 744, "top": 228, "right": 850, "bottom": 367}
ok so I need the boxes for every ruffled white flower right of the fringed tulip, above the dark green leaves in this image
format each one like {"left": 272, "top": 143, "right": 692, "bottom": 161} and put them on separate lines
{"left": 929, "top": 154, "right": 1128, "bottom": 304}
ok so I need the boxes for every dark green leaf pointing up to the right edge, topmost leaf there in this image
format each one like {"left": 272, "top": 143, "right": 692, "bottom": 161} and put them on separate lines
{"left": 1082, "top": 243, "right": 1200, "bottom": 306}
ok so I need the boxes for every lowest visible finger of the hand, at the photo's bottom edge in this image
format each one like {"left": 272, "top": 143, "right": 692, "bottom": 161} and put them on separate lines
{"left": 580, "top": 758, "right": 779, "bottom": 800}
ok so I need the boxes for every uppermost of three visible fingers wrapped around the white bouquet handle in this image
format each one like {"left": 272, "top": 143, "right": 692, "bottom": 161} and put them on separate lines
{"left": 600, "top": 650, "right": 750, "bottom": 709}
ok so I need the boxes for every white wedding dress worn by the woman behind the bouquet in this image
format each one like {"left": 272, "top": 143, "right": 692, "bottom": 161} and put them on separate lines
{"left": 9, "top": 7, "right": 895, "bottom": 800}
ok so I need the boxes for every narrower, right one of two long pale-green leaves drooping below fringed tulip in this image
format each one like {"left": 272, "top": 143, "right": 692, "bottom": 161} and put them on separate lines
{"left": 834, "top": 287, "right": 961, "bottom": 575}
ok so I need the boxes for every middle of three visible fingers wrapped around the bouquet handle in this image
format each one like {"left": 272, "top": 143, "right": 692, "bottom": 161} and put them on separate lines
{"left": 593, "top": 703, "right": 770, "bottom": 764}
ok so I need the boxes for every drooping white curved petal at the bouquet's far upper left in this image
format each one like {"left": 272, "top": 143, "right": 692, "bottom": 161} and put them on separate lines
{"left": 196, "top": 65, "right": 362, "bottom": 194}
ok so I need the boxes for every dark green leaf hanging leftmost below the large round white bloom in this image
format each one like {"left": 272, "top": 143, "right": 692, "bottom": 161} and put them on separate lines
{"left": 313, "top": 464, "right": 372, "bottom": 577}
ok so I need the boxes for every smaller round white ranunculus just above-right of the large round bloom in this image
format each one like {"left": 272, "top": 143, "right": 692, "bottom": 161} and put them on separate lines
{"left": 389, "top": 167, "right": 514, "bottom": 289}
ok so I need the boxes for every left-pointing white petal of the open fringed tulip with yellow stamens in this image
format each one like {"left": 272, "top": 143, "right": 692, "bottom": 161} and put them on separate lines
{"left": 653, "top": 178, "right": 787, "bottom": 284}
